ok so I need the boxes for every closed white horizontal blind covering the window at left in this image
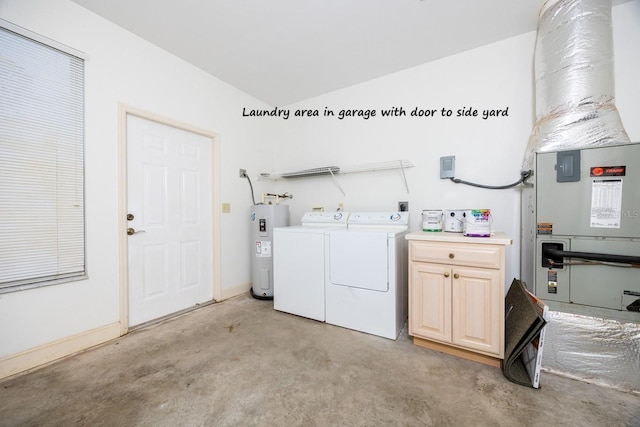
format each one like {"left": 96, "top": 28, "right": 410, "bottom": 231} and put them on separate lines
{"left": 0, "top": 21, "right": 86, "bottom": 293}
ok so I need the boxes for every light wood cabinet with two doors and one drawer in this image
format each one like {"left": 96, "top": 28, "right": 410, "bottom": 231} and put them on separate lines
{"left": 407, "top": 232, "right": 511, "bottom": 366}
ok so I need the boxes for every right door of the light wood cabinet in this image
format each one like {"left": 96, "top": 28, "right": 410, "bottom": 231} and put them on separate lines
{"left": 452, "top": 268, "right": 504, "bottom": 357}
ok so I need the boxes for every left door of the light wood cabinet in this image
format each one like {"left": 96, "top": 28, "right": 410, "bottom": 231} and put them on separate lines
{"left": 409, "top": 263, "right": 451, "bottom": 343}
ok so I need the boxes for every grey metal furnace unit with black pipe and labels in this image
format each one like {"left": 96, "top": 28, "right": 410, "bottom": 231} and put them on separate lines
{"left": 521, "top": 143, "right": 640, "bottom": 322}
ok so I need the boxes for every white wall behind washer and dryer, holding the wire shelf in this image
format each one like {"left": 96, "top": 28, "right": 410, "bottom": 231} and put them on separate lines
{"left": 274, "top": 1, "right": 640, "bottom": 286}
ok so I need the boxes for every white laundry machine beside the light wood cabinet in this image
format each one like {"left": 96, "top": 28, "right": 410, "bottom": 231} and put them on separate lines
{"left": 325, "top": 212, "right": 409, "bottom": 340}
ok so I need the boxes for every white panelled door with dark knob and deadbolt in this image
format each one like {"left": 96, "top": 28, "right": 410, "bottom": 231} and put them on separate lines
{"left": 127, "top": 115, "right": 213, "bottom": 326}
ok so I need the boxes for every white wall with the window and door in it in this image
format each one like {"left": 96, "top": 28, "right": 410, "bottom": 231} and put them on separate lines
{"left": 0, "top": 0, "right": 274, "bottom": 368}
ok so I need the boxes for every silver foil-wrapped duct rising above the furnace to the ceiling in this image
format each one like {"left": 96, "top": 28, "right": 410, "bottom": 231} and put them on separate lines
{"left": 522, "top": 0, "right": 630, "bottom": 170}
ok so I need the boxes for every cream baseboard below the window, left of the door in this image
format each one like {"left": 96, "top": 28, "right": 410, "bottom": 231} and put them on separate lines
{"left": 0, "top": 322, "right": 120, "bottom": 379}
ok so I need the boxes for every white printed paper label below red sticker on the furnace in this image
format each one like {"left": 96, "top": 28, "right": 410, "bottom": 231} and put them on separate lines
{"left": 590, "top": 179, "right": 622, "bottom": 228}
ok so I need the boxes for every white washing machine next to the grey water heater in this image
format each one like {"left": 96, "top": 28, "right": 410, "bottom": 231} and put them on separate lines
{"left": 273, "top": 212, "right": 349, "bottom": 322}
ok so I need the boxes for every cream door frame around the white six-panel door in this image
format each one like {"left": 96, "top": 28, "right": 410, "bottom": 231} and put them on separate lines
{"left": 118, "top": 104, "right": 222, "bottom": 335}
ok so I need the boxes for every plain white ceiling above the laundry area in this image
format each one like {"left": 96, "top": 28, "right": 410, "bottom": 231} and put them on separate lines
{"left": 67, "top": 0, "right": 624, "bottom": 106}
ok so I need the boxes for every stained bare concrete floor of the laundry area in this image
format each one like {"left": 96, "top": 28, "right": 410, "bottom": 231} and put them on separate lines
{"left": 0, "top": 295, "right": 640, "bottom": 427}
